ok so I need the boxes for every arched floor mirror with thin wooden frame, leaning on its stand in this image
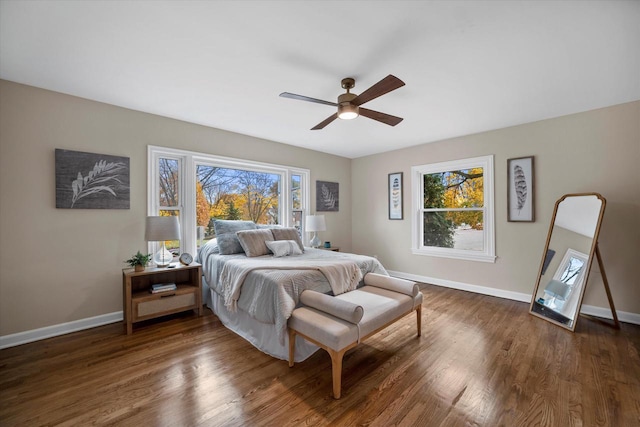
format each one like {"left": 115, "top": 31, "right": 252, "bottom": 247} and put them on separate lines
{"left": 529, "top": 193, "right": 619, "bottom": 331}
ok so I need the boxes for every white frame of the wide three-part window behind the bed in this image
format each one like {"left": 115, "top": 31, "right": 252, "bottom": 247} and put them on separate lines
{"left": 147, "top": 145, "right": 311, "bottom": 260}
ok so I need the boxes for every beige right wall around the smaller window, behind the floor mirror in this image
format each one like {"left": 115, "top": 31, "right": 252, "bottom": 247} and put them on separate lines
{"left": 351, "top": 102, "right": 640, "bottom": 314}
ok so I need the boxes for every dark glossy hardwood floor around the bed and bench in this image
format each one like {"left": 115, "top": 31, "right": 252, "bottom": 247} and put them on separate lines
{"left": 0, "top": 285, "right": 640, "bottom": 427}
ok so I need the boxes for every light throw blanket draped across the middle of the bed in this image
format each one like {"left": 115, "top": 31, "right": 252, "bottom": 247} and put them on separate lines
{"left": 220, "top": 258, "right": 362, "bottom": 312}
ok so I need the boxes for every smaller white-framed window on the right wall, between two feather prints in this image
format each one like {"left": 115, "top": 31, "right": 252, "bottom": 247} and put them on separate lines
{"left": 411, "top": 156, "right": 495, "bottom": 262}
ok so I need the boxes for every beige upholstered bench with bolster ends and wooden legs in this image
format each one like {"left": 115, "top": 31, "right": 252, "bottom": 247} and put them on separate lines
{"left": 288, "top": 273, "right": 422, "bottom": 399}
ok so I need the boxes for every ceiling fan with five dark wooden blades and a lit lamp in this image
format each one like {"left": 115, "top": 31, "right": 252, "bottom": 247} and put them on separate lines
{"left": 280, "top": 74, "right": 404, "bottom": 130}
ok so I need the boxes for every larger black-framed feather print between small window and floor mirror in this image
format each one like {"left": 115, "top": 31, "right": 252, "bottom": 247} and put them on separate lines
{"left": 507, "top": 156, "right": 535, "bottom": 222}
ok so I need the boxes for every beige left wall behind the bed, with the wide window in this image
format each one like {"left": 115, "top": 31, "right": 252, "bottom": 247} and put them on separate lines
{"left": 0, "top": 81, "right": 351, "bottom": 336}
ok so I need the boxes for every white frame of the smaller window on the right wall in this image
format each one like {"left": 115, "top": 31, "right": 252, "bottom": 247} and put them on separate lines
{"left": 411, "top": 155, "right": 496, "bottom": 262}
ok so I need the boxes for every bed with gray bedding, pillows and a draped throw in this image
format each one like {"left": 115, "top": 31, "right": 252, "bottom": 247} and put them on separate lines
{"left": 196, "top": 221, "right": 388, "bottom": 362}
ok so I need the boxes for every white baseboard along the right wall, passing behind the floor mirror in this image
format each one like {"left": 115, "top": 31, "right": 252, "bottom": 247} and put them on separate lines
{"left": 389, "top": 270, "right": 640, "bottom": 325}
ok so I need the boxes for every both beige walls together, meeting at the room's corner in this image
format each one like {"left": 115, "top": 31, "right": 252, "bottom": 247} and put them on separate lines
{"left": 0, "top": 80, "right": 640, "bottom": 336}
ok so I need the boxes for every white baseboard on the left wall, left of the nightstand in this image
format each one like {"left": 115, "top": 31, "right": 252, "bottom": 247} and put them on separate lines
{"left": 0, "top": 311, "right": 124, "bottom": 349}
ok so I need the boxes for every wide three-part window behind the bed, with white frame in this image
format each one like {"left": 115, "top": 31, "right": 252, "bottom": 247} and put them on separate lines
{"left": 148, "top": 146, "right": 309, "bottom": 254}
